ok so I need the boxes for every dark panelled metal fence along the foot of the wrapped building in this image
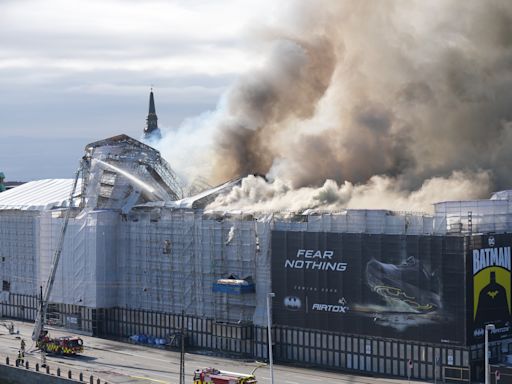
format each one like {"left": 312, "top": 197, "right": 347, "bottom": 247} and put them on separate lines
{"left": 0, "top": 295, "right": 470, "bottom": 380}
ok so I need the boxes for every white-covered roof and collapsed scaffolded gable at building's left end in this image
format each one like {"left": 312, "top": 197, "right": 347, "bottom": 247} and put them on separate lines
{"left": 0, "top": 135, "right": 241, "bottom": 213}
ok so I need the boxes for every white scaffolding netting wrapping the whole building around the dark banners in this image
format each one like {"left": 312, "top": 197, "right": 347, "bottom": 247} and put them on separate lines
{"left": 0, "top": 136, "right": 512, "bottom": 325}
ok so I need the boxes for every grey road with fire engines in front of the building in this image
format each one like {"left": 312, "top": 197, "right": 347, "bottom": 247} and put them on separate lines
{"left": 0, "top": 321, "right": 418, "bottom": 384}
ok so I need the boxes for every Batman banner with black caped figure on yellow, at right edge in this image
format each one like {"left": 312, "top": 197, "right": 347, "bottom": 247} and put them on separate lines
{"left": 467, "top": 234, "right": 512, "bottom": 344}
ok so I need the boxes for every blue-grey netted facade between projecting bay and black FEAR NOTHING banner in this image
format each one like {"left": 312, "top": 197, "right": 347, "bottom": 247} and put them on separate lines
{"left": 118, "top": 210, "right": 257, "bottom": 321}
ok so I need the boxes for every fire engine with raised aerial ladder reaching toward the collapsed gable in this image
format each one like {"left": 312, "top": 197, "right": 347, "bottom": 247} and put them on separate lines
{"left": 32, "top": 157, "right": 88, "bottom": 355}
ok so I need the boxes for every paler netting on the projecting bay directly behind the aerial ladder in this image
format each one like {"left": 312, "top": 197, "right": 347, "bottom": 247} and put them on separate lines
{"left": 38, "top": 211, "right": 119, "bottom": 308}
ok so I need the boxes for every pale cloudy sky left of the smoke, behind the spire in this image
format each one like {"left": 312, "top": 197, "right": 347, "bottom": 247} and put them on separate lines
{"left": 0, "top": 0, "right": 273, "bottom": 181}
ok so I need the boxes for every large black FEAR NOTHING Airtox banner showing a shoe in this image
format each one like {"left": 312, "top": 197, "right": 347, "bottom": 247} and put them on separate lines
{"left": 272, "top": 231, "right": 466, "bottom": 344}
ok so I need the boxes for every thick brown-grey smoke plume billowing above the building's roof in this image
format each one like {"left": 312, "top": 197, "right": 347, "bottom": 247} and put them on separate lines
{"left": 158, "top": 0, "right": 512, "bottom": 209}
